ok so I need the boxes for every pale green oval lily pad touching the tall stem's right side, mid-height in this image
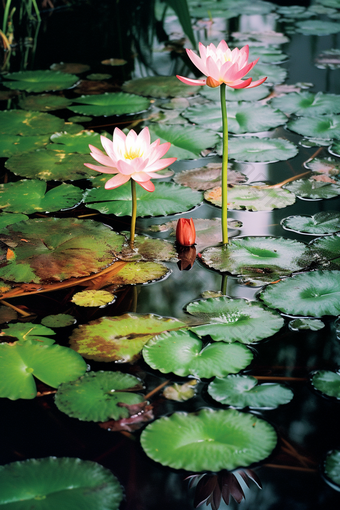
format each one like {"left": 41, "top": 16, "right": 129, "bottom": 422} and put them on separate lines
{"left": 224, "top": 136, "right": 299, "bottom": 163}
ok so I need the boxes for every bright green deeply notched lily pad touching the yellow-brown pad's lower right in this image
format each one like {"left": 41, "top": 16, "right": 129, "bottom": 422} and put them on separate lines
{"left": 143, "top": 330, "right": 253, "bottom": 379}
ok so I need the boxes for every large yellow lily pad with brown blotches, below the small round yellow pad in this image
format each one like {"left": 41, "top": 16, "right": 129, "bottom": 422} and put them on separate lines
{"left": 70, "top": 313, "right": 185, "bottom": 363}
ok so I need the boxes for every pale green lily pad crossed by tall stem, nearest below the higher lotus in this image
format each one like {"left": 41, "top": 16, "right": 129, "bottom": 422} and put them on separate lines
{"left": 181, "top": 102, "right": 287, "bottom": 134}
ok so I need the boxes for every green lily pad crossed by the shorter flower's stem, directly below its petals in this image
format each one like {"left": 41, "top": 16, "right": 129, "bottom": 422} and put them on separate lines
{"left": 84, "top": 182, "right": 203, "bottom": 216}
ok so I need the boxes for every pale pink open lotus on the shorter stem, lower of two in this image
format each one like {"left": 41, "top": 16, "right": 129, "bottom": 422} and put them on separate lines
{"left": 84, "top": 127, "right": 177, "bottom": 191}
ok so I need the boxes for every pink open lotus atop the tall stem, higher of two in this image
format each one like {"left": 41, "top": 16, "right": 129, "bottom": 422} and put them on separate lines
{"left": 177, "top": 41, "right": 267, "bottom": 89}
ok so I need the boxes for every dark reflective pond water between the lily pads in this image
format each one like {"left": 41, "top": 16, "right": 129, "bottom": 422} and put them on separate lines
{"left": 0, "top": 0, "right": 340, "bottom": 510}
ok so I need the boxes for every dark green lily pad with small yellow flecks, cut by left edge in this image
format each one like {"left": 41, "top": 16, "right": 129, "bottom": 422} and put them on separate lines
{"left": 0, "top": 110, "right": 64, "bottom": 136}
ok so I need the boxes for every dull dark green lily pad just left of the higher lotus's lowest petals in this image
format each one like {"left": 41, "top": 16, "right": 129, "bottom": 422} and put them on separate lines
{"left": 122, "top": 76, "right": 202, "bottom": 97}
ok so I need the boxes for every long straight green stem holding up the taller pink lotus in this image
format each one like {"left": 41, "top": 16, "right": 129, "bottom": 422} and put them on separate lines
{"left": 220, "top": 83, "right": 228, "bottom": 244}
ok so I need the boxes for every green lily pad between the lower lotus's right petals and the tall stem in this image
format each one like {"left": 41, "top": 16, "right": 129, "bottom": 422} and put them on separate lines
{"left": 149, "top": 124, "right": 220, "bottom": 160}
